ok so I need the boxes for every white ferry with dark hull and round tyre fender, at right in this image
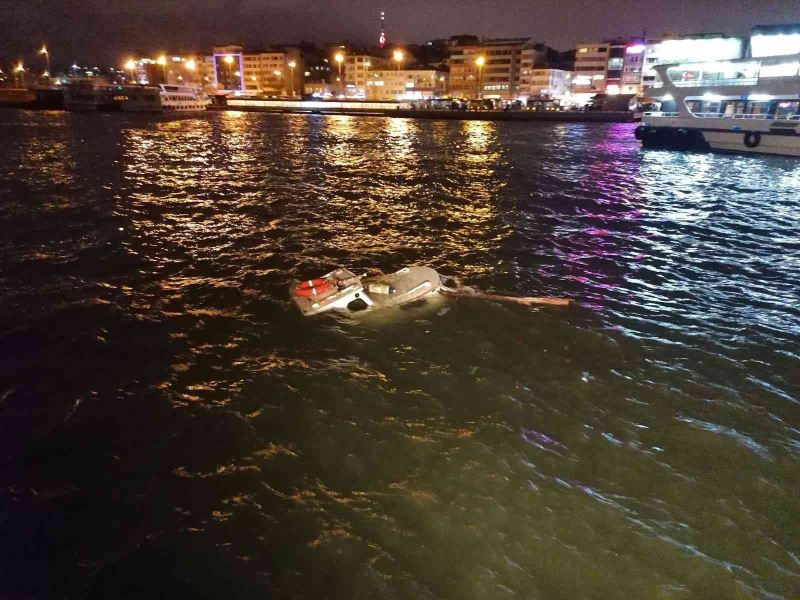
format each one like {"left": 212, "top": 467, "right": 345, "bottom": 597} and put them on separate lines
{"left": 635, "top": 54, "right": 800, "bottom": 156}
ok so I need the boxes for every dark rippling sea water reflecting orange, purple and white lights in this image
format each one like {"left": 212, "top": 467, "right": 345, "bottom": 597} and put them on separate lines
{"left": 0, "top": 110, "right": 800, "bottom": 600}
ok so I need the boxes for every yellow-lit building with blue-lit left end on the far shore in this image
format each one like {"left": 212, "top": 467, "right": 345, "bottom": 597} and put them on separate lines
{"left": 204, "top": 46, "right": 304, "bottom": 96}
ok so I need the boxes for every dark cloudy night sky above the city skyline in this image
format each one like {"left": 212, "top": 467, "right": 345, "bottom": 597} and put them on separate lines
{"left": 0, "top": 0, "right": 800, "bottom": 65}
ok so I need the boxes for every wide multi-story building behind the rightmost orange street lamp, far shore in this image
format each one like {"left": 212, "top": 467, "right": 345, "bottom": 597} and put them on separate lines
{"left": 450, "top": 38, "right": 530, "bottom": 100}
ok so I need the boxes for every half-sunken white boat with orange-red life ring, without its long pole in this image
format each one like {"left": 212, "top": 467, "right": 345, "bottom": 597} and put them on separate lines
{"left": 290, "top": 267, "right": 442, "bottom": 317}
